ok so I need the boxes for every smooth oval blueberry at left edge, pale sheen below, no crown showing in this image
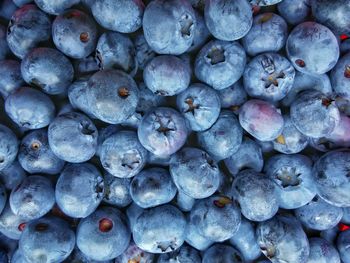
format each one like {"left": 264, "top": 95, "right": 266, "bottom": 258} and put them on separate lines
{"left": 5, "top": 87, "right": 55, "bottom": 129}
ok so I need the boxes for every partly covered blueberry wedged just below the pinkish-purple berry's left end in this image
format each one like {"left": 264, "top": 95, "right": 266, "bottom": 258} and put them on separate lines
{"left": 225, "top": 137, "right": 264, "bottom": 176}
